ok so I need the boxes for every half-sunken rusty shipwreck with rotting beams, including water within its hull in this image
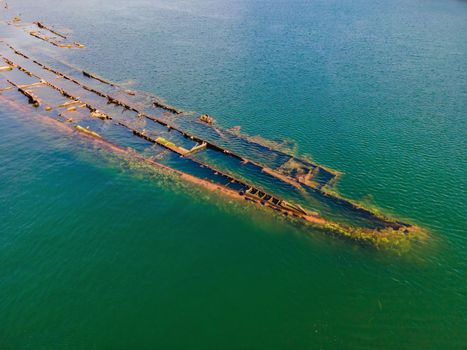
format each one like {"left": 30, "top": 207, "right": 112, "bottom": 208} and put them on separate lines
{"left": 0, "top": 9, "right": 422, "bottom": 246}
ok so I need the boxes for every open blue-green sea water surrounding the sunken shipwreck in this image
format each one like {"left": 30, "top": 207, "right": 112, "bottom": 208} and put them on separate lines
{"left": 0, "top": 0, "right": 467, "bottom": 349}
